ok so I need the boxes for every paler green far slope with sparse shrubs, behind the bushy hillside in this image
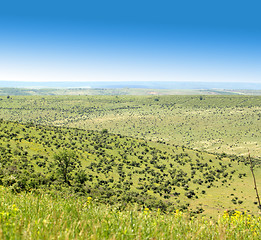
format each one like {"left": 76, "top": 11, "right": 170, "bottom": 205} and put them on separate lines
{"left": 0, "top": 95, "right": 261, "bottom": 158}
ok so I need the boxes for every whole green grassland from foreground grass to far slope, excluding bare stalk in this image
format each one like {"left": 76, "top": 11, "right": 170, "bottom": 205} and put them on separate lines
{"left": 0, "top": 95, "right": 261, "bottom": 239}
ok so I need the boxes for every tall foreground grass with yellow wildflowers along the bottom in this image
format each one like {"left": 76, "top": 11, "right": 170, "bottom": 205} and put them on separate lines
{"left": 0, "top": 187, "right": 261, "bottom": 239}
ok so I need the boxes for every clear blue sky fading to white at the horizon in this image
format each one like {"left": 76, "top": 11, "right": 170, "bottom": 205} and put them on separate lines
{"left": 0, "top": 0, "right": 261, "bottom": 83}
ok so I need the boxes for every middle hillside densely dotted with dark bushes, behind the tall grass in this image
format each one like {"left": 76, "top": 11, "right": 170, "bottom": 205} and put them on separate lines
{"left": 0, "top": 121, "right": 261, "bottom": 216}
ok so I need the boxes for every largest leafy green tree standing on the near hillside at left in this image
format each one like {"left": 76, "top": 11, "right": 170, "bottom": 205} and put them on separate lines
{"left": 54, "top": 150, "right": 79, "bottom": 185}
